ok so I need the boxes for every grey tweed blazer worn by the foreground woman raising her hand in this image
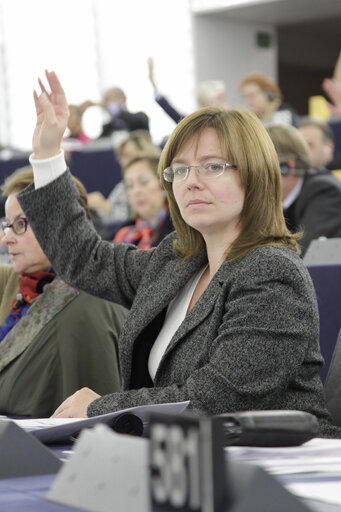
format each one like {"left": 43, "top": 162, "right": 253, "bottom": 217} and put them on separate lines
{"left": 18, "top": 171, "right": 334, "bottom": 435}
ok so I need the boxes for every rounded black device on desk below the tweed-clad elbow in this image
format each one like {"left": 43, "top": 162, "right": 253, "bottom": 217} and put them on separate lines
{"left": 215, "top": 410, "right": 319, "bottom": 446}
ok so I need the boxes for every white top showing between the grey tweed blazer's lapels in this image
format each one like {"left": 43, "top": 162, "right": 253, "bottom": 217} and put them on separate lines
{"left": 148, "top": 265, "right": 207, "bottom": 380}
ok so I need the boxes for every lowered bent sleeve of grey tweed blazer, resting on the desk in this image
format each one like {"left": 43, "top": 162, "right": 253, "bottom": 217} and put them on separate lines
{"left": 88, "top": 250, "right": 322, "bottom": 416}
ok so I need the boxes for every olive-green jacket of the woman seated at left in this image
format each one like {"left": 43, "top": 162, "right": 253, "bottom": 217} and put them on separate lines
{"left": 0, "top": 265, "right": 127, "bottom": 417}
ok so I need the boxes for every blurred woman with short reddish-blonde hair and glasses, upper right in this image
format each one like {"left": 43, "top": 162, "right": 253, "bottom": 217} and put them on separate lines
{"left": 239, "top": 73, "right": 299, "bottom": 126}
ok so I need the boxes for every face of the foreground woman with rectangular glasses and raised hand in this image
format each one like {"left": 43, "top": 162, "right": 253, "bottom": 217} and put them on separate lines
{"left": 172, "top": 128, "right": 245, "bottom": 242}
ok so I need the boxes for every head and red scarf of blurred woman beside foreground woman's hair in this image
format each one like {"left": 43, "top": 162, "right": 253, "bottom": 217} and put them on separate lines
{"left": 113, "top": 153, "right": 174, "bottom": 249}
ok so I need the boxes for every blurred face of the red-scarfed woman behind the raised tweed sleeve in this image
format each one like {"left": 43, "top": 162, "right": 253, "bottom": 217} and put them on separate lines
{"left": 124, "top": 160, "right": 165, "bottom": 220}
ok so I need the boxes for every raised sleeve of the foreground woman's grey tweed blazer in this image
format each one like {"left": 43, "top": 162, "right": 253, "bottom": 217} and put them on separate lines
{"left": 18, "top": 171, "right": 153, "bottom": 308}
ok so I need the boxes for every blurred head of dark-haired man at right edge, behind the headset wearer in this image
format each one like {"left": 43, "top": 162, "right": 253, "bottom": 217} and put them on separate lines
{"left": 298, "top": 117, "right": 341, "bottom": 170}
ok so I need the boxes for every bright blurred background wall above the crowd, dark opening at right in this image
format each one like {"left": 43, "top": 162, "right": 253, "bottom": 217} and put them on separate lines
{"left": 0, "top": 0, "right": 341, "bottom": 149}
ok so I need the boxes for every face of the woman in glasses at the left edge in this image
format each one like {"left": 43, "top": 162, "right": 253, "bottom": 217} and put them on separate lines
{"left": 2, "top": 194, "right": 51, "bottom": 274}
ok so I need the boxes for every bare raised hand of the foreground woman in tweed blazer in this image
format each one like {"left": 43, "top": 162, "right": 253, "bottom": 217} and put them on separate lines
{"left": 33, "top": 71, "right": 69, "bottom": 159}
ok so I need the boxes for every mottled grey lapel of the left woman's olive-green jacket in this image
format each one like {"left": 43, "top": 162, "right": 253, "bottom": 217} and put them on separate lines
{"left": 0, "top": 277, "right": 79, "bottom": 371}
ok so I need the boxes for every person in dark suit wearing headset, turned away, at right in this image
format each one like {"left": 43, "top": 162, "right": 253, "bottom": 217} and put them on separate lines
{"left": 267, "top": 125, "right": 341, "bottom": 255}
